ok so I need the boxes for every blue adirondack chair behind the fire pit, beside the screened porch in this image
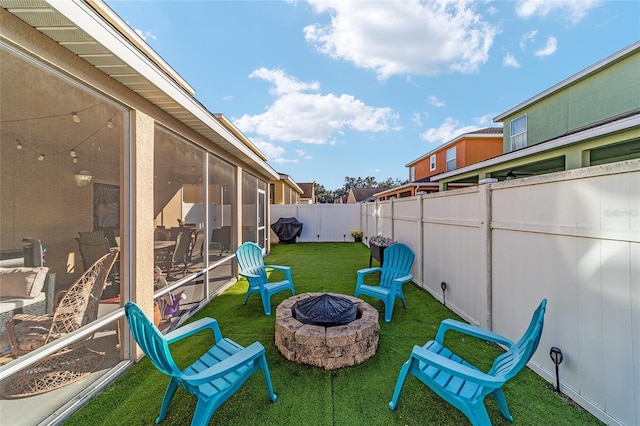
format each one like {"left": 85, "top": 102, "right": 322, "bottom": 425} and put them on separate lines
{"left": 236, "top": 242, "right": 295, "bottom": 315}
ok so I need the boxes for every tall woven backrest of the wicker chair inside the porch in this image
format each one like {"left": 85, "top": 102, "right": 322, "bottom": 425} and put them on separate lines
{"left": 51, "top": 250, "right": 120, "bottom": 334}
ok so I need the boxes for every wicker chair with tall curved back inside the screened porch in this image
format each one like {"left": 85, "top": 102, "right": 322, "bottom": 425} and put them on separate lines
{"left": 6, "top": 250, "right": 119, "bottom": 357}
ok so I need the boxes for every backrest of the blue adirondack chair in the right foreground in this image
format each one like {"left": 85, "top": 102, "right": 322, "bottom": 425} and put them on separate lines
{"left": 488, "top": 299, "right": 547, "bottom": 381}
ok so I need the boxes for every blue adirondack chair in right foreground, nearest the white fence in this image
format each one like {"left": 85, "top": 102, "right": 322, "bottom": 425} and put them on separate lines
{"left": 389, "top": 299, "right": 547, "bottom": 425}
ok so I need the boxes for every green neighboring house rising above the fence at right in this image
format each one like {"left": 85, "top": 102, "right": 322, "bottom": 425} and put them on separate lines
{"left": 432, "top": 42, "right": 640, "bottom": 189}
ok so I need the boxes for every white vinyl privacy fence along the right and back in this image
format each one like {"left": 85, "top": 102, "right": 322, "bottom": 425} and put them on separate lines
{"left": 271, "top": 160, "right": 640, "bottom": 426}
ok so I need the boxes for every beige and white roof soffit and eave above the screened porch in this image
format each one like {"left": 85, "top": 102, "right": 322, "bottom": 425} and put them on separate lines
{"left": 0, "top": 0, "right": 278, "bottom": 179}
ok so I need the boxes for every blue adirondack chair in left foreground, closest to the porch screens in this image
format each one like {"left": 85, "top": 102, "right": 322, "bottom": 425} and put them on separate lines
{"left": 124, "top": 302, "right": 277, "bottom": 425}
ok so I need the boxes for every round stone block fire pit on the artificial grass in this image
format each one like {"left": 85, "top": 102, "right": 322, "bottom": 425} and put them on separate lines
{"left": 275, "top": 293, "right": 380, "bottom": 370}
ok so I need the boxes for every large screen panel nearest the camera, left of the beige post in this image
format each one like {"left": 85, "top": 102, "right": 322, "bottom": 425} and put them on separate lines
{"left": 0, "top": 43, "right": 129, "bottom": 424}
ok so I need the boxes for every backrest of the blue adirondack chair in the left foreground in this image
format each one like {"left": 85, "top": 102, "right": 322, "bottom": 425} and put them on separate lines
{"left": 124, "top": 302, "right": 181, "bottom": 377}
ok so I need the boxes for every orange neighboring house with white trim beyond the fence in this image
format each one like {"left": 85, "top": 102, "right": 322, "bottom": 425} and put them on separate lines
{"left": 377, "top": 127, "right": 503, "bottom": 200}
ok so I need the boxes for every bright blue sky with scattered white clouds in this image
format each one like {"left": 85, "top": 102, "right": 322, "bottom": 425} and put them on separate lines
{"left": 106, "top": 0, "right": 640, "bottom": 190}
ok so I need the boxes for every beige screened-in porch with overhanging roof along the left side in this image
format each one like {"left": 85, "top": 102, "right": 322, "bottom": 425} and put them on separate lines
{"left": 0, "top": 0, "right": 278, "bottom": 424}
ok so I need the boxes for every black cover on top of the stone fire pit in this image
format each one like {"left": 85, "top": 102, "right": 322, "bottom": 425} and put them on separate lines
{"left": 293, "top": 294, "right": 358, "bottom": 327}
